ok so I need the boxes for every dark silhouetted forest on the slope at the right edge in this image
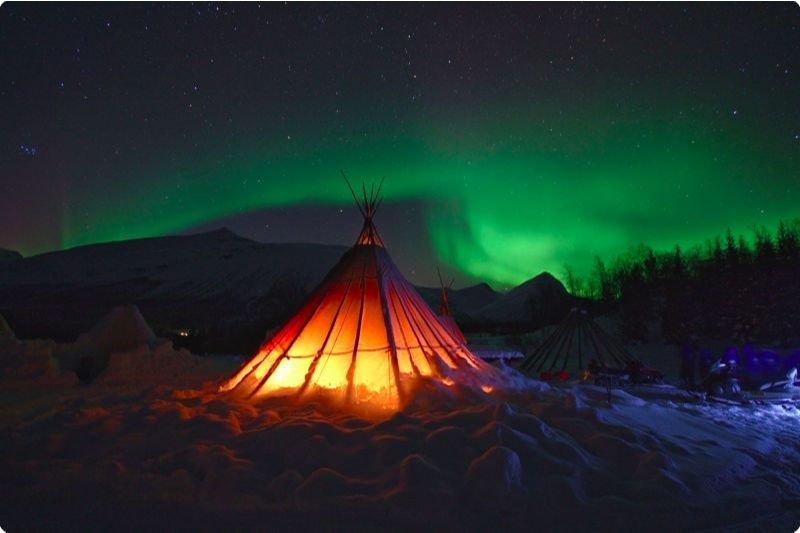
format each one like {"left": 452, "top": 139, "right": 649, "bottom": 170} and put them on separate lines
{"left": 564, "top": 219, "right": 800, "bottom": 346}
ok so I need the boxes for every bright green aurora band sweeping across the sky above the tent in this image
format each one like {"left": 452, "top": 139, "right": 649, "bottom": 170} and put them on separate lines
{"left": 62, "top": 103, "right": 800, "bottom": 287}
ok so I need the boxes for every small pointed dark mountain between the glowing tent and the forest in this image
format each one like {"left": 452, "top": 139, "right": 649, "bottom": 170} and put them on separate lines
{"left": 473, "top": 272, "right": 575, "bottom": 326}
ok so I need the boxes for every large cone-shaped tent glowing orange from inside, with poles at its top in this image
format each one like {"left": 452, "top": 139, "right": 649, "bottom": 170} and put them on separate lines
{"left": 216, "top": 182, "right": 497, "bottom": 411}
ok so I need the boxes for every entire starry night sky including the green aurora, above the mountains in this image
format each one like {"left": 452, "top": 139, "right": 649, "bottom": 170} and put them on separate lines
{"left": 0, "top": 2, "right": 800, "bottom": 287}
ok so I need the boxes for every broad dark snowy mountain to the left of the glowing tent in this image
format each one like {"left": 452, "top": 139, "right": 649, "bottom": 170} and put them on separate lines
{"left": 0, "top": 229, "right": 345, "bottom": 351}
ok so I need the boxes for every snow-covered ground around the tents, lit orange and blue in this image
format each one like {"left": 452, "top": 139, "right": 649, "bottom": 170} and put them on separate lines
{"left": 0, "top": 339, "right": 800, "bottom": 531}
